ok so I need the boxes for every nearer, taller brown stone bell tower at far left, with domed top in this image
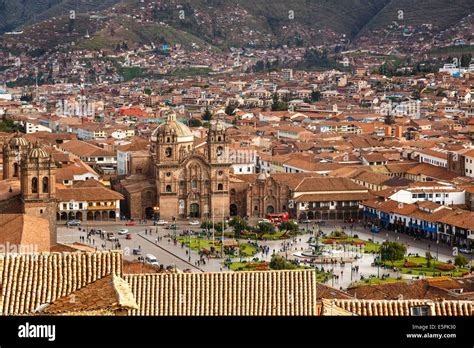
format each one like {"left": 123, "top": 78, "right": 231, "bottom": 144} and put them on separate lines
{"left": 20, "top": 143, "right": 57, "bottom": 245}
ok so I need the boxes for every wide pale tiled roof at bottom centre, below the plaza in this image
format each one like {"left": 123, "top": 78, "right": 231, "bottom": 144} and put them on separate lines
{"left": 124, "top": 270, "right": 316, "bottom": 316}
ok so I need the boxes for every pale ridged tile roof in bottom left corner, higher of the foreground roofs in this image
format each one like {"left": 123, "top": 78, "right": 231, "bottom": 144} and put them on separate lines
{"left": 0, "top": 251, "right": 122, "bottom": 315}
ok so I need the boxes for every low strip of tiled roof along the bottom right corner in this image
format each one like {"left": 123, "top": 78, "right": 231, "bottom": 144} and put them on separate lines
{"left": 323, "top": 299, "right": 474, "bottom": 316}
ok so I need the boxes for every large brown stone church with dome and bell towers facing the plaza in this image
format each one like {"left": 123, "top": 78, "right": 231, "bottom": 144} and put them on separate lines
{"left": 115, "top": 114, "right": 231, "bottom": 219}
